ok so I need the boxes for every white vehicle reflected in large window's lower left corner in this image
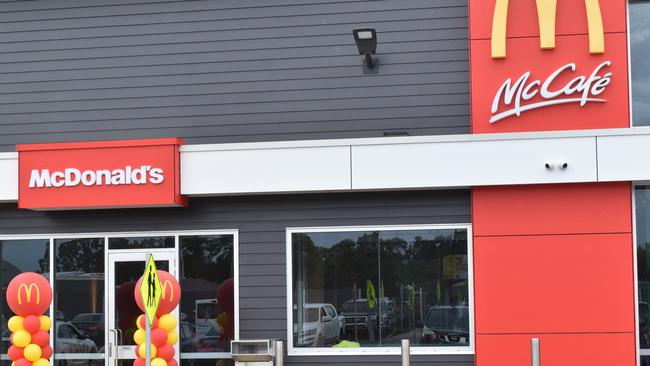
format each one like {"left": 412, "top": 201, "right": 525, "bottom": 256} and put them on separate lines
{"left": 293, "top": 304, "right": 345, "bottom": 347}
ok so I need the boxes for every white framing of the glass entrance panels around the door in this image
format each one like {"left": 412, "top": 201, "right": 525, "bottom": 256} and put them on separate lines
{"left": 0, "top": 229, "right": 240, "bottom": 364}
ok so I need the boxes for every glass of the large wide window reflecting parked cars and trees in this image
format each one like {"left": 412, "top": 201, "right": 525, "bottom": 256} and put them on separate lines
{"left": 291, "top": 229, "right": 470, "bottom": 347}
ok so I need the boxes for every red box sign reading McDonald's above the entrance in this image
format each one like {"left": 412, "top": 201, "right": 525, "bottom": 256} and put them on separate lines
{"left": 17, "top": 138, "right": 186, "bottom": 210}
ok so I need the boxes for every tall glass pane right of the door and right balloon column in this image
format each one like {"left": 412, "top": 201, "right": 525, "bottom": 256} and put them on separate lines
{"left": 179, "top": 235, "right": 235, "bottom": 354}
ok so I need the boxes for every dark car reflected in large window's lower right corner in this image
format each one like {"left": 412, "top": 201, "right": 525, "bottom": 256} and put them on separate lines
{"left": 421, "top": 306, "right": 469, "bottom": 346}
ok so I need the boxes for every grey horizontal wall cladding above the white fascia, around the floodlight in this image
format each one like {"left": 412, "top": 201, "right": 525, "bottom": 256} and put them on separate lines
{"left": 0, "top": 0, "right": 469, "bottom": 151}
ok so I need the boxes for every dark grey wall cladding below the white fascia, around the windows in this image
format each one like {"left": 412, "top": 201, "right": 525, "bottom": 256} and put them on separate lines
{"left": 0, "top": 190, "right": 473, "bottom": 366}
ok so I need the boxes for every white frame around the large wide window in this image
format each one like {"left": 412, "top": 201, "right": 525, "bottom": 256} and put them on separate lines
{"left": 286, "top": 223, "right": 476, "bottom": 356}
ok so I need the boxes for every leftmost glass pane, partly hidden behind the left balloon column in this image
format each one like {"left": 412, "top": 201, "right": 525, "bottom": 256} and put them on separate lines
{"left": 0, "top": 239, "right": 50, "bottom": 354}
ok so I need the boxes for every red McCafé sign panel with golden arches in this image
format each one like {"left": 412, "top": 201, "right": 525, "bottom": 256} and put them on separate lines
{"left": 470, "top": 0, "right": 629, "bottom": 133}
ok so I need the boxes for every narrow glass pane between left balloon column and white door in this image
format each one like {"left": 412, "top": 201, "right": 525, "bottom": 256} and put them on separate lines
{"left": 54, "top": 239, "right": 104, "bottom": 354}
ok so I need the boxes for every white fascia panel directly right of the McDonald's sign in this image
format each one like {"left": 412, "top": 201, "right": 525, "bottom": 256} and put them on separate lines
{"left": 181, "top": 146, "right": 351, "bottom": 195}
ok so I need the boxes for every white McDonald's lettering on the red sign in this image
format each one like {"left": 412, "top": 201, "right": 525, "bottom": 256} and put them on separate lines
{"left": 29, "top": 165, "right": 165, "bottom": 188}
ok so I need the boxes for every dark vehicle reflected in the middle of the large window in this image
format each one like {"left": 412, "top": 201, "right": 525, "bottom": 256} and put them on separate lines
{"left": 341, "top": 298, "right": 396, "bottom": 338}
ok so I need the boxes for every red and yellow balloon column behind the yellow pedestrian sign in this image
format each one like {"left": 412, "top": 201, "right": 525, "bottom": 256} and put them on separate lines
{"left": 133, "top": 270, "right": 181, "bottom": 366}
